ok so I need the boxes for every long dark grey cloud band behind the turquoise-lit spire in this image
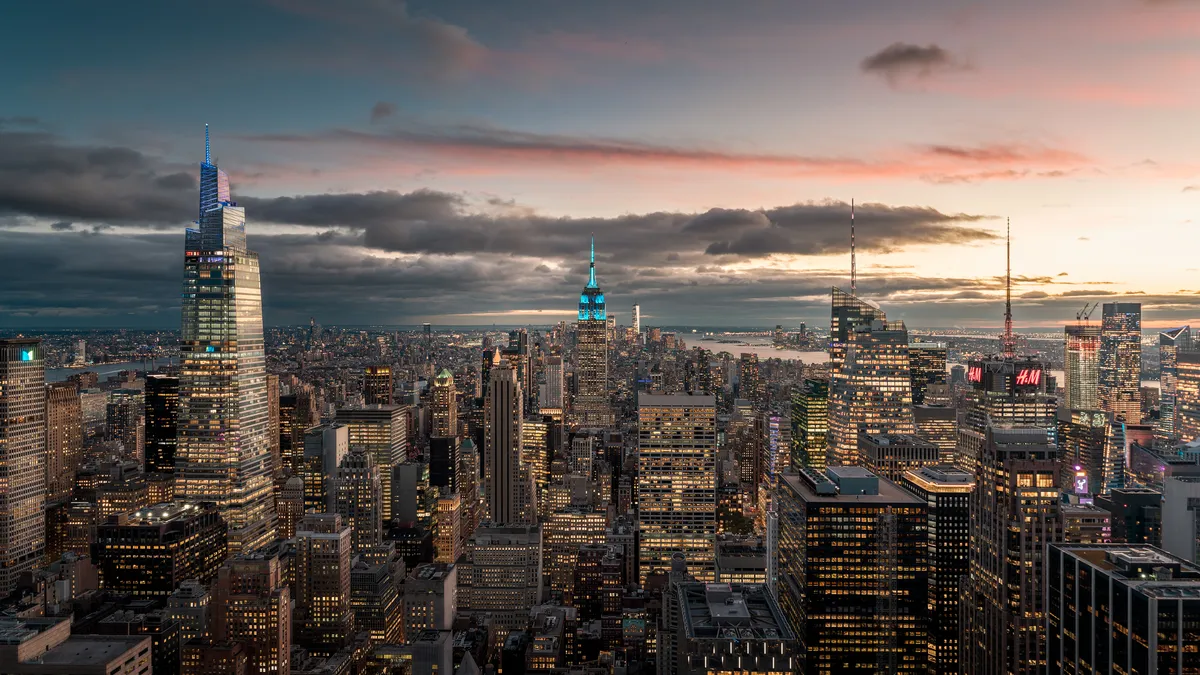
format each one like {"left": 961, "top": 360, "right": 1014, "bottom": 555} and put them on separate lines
{"left": 240, "top": 190, "right": 995, "bottom": 263}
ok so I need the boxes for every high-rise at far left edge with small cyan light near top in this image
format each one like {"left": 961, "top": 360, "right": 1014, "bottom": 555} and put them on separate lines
{"left": 0, "top": 338, "right": 46, "bottom": 595}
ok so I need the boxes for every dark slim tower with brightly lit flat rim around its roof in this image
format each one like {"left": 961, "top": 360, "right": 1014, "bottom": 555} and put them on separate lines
{"left": 899, "top": 465, "right": 974, "bottom": 675}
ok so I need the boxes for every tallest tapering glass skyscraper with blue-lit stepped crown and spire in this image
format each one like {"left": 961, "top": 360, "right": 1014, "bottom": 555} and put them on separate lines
{"left": 175, "top": 132, "right": 276, "bottom": 552}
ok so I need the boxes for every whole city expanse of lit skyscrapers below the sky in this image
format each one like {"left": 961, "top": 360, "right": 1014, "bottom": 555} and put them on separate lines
{"left": 0, "top": 132, "right": 1200, "bottom": 675}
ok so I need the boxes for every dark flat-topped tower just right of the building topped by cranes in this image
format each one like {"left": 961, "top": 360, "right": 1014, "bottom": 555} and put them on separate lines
{"left": 1099, "top": 303, "right": 1141, "bottom": 424}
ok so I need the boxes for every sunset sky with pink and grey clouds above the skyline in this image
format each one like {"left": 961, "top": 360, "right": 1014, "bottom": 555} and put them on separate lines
{"left": 0, "top": 0, "right": 1200, "bottom": 328}
